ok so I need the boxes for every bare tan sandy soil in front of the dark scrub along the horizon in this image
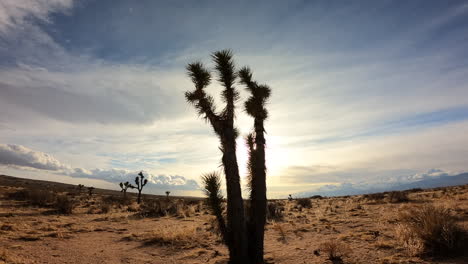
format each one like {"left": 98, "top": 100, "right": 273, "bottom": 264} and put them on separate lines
{"left": 0, "top": 176, "right": 468, "bottom": 264}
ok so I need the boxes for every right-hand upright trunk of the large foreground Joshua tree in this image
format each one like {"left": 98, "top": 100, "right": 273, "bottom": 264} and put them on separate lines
{"left": 239, "top": 67, "right": 271, "bottom": 263}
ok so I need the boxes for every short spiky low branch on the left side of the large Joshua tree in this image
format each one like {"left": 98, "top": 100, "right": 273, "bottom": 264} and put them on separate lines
{"left": 202, "top": 172, "right": 227, "bottom": 244}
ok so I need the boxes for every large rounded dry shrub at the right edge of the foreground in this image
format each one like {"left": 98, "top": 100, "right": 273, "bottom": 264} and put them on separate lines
{"left": 397, "top": 205, "right": 468, "bottom": 256}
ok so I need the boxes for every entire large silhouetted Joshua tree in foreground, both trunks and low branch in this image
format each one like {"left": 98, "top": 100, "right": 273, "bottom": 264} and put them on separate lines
{"left": 185, "top": 50, "right": 271, "bottom": 264}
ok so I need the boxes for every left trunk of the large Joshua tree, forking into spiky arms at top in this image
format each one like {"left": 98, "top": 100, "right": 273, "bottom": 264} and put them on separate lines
{"left": 185, "top": 50, "right": 249, "bottom": 264}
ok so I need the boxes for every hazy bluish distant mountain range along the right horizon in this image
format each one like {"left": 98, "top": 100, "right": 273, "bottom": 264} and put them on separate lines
{"left": 295, "top": 172, "right": 468, "bottom": 197}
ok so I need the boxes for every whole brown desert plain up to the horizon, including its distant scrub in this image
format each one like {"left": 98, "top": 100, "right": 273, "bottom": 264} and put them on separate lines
{"left": 0, "top": 176, "right": 468, "bottom": 264}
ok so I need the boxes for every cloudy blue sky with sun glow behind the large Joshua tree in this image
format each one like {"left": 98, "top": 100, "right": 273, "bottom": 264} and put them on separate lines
{"left": 0, "top": 0, "right": 468, "bottom": 197}
